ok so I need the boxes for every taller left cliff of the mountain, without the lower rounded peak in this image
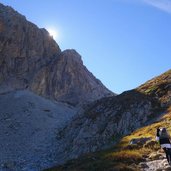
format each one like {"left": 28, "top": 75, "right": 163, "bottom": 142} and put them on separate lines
{"left": 0, "top": 4, "right": 61, "bottom": 87}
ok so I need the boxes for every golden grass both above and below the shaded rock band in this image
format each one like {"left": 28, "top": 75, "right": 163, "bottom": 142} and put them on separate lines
{"left": 44, "top": 70, "right": 171, "bottom": 171}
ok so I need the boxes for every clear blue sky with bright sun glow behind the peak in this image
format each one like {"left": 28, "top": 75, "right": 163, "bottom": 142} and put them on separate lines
{"left": 0, "top": 0, "right": 171, "bottom": 94}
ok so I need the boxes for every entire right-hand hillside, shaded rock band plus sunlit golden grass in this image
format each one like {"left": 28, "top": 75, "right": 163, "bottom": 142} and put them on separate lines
{"left": 45, "top": 70, "right": 171, "bottom": 170}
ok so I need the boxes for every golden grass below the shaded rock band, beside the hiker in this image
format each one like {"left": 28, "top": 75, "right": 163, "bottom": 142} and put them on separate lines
{"left": 46, "top": 107, "right": 171, "bottom": 171}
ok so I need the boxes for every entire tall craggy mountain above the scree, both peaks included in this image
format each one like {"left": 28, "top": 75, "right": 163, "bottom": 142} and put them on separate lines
{"left": 0, "top": 4, "right": 113, "bottom": 105}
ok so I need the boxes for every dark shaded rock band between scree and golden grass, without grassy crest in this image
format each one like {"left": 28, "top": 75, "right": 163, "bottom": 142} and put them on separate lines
{"left": 58, "top": 91, "right": 159, "bottom": 160}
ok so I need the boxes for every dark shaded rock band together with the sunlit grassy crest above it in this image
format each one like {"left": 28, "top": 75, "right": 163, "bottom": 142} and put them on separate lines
{"left": 58, "top": 70, "right": 171, "bottom": 160}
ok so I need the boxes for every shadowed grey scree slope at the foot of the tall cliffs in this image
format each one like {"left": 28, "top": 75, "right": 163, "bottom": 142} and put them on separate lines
{"left": 0, "top": 91, "right": 76, "bottom": 171}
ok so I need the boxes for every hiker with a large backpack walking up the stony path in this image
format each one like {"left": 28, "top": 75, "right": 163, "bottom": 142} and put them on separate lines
{"left": 156, "top": 128, "right": 171, "bottom": 165}
